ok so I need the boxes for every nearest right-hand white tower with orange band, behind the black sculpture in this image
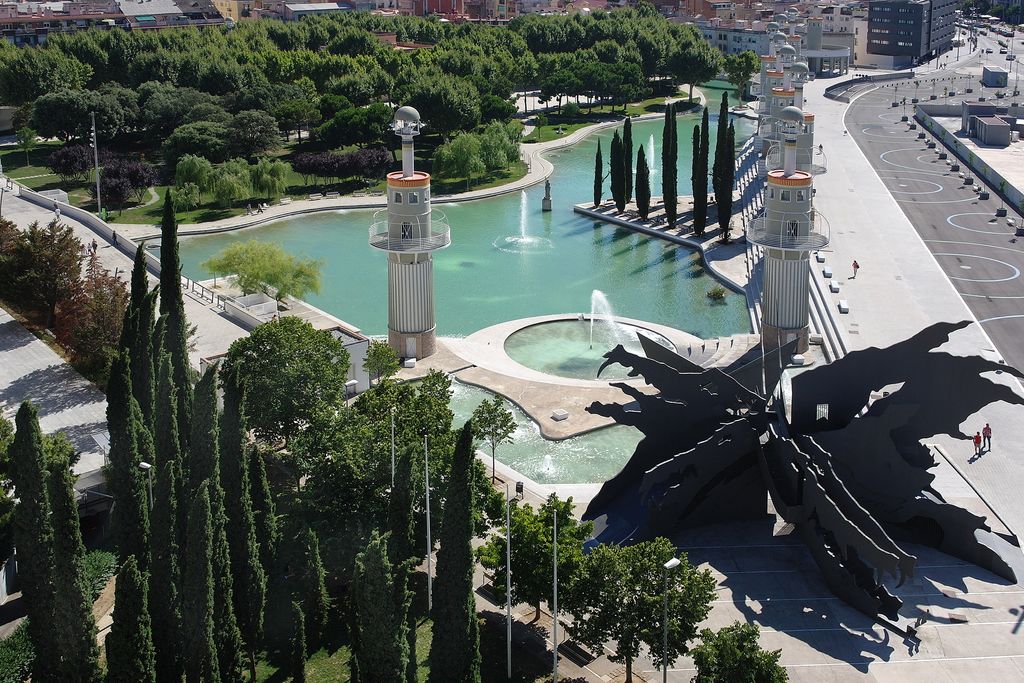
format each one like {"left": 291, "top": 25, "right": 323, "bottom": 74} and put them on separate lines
{"left": 746, "top": 106, "right": 828, "bottom": 352}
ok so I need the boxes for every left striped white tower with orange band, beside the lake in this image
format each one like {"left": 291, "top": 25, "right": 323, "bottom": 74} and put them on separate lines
{"left": 370, "top": 106, "right": 452, "bottom": 358}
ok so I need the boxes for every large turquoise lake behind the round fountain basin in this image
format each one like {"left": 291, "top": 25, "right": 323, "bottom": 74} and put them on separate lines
{"left": 180, "top": 99, "right": 754, "bottom": 338}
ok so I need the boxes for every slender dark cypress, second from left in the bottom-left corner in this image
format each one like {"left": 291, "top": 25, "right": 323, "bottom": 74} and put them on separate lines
{"left": 49, "top": 452, "right": 100, "bottom": 683}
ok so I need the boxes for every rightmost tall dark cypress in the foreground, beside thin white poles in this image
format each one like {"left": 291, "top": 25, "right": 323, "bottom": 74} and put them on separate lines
{"left": 427, "top": 422, "right": 480, "bottom": 683}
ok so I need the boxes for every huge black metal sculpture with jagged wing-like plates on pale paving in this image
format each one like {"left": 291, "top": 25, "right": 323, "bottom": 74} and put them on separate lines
{"left": 584, "top": 322, "right": 1024, "bottom": 621}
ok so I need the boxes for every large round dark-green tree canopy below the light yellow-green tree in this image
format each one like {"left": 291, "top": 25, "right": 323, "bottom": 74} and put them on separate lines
{"left": 224, "top": 316, "right": 348, "bottom": 441}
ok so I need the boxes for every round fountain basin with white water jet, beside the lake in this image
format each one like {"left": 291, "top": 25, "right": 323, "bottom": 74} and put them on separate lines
{"left": 505, "top": 318, "right": 676, "bottom": 380}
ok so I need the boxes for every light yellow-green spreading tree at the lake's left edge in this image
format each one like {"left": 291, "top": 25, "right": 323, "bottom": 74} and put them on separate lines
{"left": 203, "top": 240, "right": 321, "bottom": 303}
